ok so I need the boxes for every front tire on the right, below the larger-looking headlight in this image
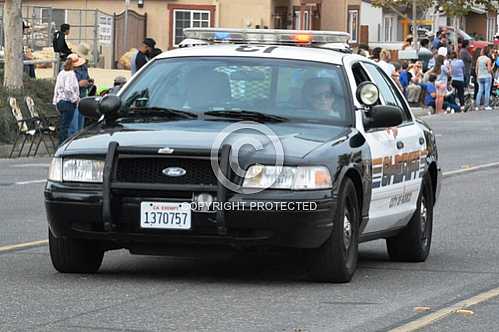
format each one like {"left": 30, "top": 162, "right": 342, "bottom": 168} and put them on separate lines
{"left": 310, "top": 178, "right": 360, "bottom": 283}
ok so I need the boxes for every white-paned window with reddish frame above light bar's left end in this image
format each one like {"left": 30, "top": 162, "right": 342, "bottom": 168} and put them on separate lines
{"left": 173, "top": 9, "right": 211, "bottom": 46}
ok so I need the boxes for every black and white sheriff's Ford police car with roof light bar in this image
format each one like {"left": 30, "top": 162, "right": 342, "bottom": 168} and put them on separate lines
{"left": 45, "top": 28, "right": 441, "bottom": 282}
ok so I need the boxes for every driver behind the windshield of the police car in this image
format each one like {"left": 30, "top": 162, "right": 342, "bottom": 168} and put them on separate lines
{"left": 303, "top": 77, "right": 340, "bottom": 118}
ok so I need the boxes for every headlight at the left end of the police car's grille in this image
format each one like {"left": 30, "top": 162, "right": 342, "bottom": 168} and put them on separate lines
{"left": 62, "top": 159, "right": 104, "bottom": 183}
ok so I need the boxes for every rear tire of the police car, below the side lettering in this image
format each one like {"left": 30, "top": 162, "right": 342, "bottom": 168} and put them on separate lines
{"left": 386, "top": 177, "right": 433, "bottom": 262}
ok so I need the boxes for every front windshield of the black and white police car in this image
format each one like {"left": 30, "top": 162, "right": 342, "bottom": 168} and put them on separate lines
{"left": 121, "top": 57, "right": 353, "bottom": 126}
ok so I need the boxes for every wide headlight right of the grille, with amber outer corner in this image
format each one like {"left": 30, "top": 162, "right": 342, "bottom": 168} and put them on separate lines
{"left": 243, "top": 165, "right": 332, "bottom": 190}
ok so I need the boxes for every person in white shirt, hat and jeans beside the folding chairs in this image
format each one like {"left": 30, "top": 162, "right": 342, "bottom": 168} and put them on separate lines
{"left": 53, "top": 54, "right": 81, "bottom": 144}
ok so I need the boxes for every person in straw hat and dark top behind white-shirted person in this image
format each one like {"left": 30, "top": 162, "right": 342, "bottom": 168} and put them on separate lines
{"left": 69, "top": 43, "right": 90, "bottom": 135}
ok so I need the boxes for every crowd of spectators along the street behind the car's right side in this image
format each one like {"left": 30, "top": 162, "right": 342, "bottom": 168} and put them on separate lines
{"left": 359, "top": 28, "right": 499, "bottom": 113}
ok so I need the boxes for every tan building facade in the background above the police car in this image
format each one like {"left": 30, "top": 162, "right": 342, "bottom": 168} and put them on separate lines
{"left": 8, "top": 0, "right": 362, "bottom": 68}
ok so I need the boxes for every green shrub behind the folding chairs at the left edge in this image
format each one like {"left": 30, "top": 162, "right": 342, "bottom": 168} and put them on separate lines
{"left": 0, "top": 71, "right": 57, "bottom": 143}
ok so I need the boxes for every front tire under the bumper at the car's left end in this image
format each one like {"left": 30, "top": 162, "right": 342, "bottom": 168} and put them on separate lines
{"left": 49, "top": 230, "right": 104, "bottom": 273}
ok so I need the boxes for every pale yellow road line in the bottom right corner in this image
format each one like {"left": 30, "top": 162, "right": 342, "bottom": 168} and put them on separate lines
{"left": 390, "top": 287, "right": 499, "bottom": 332}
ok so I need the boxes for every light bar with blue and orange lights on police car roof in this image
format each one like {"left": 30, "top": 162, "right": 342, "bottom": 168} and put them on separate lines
{"left": 184, "top": 28, "right": 350, "bottom": 45}
